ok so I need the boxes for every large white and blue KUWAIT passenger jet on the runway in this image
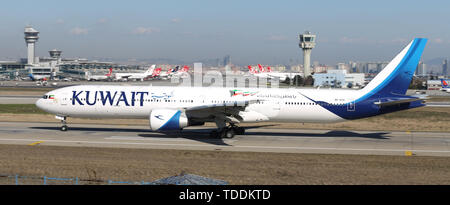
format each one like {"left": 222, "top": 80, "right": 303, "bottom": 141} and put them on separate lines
{"left": 36, "top": 38, "right": 427, "bottom": 138}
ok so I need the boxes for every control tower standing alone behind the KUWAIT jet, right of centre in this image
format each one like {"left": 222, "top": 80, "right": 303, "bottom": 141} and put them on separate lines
{"left": 298, "top": 31, "right": 316, "bottom": 78}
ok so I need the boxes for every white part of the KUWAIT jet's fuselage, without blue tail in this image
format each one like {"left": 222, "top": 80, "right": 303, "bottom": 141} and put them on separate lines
{"left": 36, "top": 85, "right": 360, "bottom": 122}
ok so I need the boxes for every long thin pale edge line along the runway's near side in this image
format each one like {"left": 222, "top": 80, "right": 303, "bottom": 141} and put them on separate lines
{"left": 0, "top": 139, "right": 450, "bottom": 153}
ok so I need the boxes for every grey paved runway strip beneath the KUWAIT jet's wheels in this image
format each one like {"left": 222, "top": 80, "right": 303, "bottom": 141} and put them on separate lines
{"left": 0, "top": 122, "right": 450, "bottom": 156}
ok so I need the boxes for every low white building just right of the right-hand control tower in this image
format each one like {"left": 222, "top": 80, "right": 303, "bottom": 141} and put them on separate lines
{"left": 313, "top": 70, "right": 365, "bottom": 88}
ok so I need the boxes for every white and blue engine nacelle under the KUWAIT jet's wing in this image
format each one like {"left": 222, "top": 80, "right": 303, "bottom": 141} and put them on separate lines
{"left": 149, "top": 109, "right": 188, "bottom": 131}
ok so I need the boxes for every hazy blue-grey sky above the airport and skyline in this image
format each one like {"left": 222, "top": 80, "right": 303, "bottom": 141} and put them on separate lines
{"left": 0, "top": 0, "right": 450, "bottom": 65}
